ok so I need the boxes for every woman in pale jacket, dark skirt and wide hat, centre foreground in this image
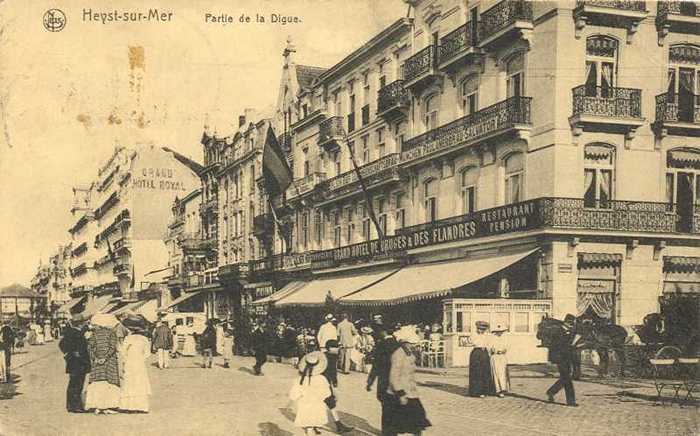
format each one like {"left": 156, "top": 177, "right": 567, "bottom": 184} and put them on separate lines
{"left": 382, "top": 325, "right": 431, "bottom": 435}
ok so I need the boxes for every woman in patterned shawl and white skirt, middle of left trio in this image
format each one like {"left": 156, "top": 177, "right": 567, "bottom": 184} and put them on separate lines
{"left": 85, "top": 313, "right": 120, "bottom": 414}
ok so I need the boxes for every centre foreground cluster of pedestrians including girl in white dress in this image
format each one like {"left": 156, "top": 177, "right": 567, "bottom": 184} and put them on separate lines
{"left": 289, "top": 314, "right": 431, "bottom": 436}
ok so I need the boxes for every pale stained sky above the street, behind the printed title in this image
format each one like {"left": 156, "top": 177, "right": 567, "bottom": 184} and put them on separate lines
{"left": 0, "top": 0, "right": 407, "bottom": 287}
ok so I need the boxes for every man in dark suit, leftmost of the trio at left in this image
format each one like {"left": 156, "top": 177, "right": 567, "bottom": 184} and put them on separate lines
{"left": 58, "top": 314, "right": 90, "bottom": 413}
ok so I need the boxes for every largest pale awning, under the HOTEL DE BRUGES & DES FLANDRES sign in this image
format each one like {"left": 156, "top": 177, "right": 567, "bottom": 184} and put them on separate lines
{"left": 340, "top": 249, "right": 537, "bottom": 306}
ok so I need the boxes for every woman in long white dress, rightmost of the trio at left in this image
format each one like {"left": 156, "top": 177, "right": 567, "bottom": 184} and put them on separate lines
{"left": 119, "top": 318, "right": 151, "bottom": 413}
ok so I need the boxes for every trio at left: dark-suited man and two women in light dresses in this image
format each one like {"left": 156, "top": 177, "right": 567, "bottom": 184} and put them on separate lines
{"left": 59, "top": 313, "right": 151, "bottom": 414}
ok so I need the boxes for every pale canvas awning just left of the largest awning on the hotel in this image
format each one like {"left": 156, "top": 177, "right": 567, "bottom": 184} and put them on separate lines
{"left": 276, "top": 267, "right": 398, "bottom": 306}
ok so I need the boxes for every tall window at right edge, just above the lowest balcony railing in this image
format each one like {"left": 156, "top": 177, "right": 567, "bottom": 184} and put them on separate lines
{"left": 666, "top": 148, "right": 700, "bottom": 232}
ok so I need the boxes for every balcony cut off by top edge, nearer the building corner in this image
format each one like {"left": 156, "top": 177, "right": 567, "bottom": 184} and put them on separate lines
{"left": 574, "top": 0, "right": 649, "bottom": 43}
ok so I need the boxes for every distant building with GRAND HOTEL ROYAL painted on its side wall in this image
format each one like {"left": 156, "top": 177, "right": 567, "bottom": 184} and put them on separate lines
{"left": 69, "top": 145, "right": 201, "bottom": 301}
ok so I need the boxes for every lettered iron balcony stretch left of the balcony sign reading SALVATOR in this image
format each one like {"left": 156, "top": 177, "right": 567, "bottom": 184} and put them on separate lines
{"left": 321, "top": 153, "right": 399, "bottom": 200}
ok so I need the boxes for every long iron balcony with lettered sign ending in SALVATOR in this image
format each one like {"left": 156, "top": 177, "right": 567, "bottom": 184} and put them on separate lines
{"left": 401, "top": 97, "right": 531, "bottom": 165}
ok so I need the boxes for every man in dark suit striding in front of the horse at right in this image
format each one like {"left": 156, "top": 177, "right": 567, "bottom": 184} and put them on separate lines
{"left": 547, "top": 314, "right": 578, "bottom": 407}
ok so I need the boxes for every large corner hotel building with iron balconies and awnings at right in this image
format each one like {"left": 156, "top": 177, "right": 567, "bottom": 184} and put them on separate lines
{"left": 253, "top": 0, "right": 700, "bottom": 365}
